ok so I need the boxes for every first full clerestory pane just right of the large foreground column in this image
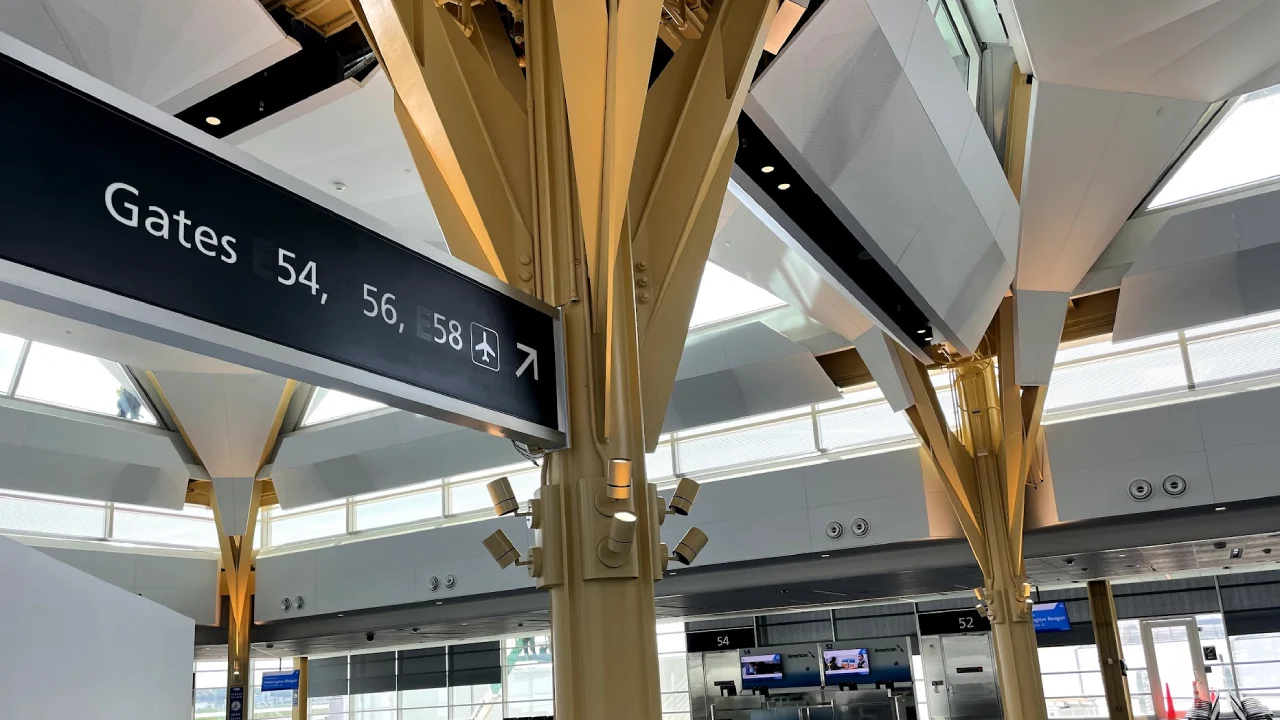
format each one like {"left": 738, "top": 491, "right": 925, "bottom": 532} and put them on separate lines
{"left": 676, "top": 415, "right": 817, "bottom": 474}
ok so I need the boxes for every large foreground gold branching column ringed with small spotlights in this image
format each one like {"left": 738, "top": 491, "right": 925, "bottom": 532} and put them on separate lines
{"left": 353, "top": 0, "right": 776, "bottom": 720}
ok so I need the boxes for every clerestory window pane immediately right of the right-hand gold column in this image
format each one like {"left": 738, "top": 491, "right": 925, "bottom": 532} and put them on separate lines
{"left": 1044, "top": 347, "right": 1187, "bottom": 411}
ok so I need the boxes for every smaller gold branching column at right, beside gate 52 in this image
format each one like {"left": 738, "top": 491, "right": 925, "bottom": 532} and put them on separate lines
{"left": 897, "top": 299, "right": 1047, "bottom": 720}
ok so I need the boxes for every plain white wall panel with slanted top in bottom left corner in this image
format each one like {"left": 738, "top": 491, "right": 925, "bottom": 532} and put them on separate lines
{"left": 0, "top": 538, "right": 195, "bottom": 720}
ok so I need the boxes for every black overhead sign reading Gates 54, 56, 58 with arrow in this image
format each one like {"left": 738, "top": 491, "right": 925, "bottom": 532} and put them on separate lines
{"left": 0, "top": 35, "right": 566, "bottom": 447}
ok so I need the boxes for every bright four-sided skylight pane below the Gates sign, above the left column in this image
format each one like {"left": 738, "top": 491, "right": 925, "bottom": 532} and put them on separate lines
{"left": 15, "top": 342, "right": 156, "bottom": 425}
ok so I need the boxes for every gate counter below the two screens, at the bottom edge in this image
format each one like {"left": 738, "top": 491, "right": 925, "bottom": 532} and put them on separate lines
{"left": 712, "top": 689, "right": 911, "bottom": 720}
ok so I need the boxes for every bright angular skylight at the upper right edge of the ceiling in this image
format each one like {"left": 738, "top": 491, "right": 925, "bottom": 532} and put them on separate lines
{"left": 1147, "top": 85, "right": 1280, "bottom": 210}
